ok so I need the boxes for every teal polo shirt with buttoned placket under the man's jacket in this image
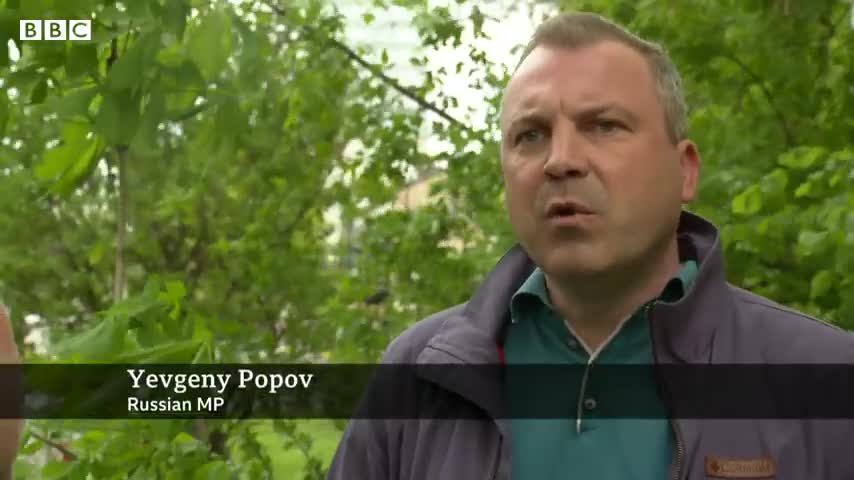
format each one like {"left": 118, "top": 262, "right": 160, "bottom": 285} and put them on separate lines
{"left": 504, "top": 260, "right": 697, "bottom": 480}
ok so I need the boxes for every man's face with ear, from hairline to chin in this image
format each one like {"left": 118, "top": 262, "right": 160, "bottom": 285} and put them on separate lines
{"left": 501, "top": 42, "right": 700, "bottom": 277}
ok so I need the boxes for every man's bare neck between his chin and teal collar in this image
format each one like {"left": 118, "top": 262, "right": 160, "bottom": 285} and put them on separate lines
{"left": 546, "top": 236, "right": 679, "bottom": 351}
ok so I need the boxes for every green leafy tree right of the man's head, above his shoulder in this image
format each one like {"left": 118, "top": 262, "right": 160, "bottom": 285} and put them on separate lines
{"left": 577, "top": 1, "right": 854, "bottom": 329}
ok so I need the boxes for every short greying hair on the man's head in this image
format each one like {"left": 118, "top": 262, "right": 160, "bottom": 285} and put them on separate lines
{"left": 508, "top": 12, "right": 688, "bottom": 143}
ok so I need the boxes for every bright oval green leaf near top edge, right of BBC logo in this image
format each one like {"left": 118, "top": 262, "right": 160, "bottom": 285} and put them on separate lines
{"left": 187, "top": 10, "right": 233, "bottom": 80}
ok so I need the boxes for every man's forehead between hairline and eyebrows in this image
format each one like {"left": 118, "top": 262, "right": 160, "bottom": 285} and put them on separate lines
{"left": 502, "top": 41, "right": 657, "bottom": 121}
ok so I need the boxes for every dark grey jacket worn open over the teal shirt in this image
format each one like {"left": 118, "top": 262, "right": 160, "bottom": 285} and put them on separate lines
{"left": 328, "top": 212, "right": 854, "bottom": 480}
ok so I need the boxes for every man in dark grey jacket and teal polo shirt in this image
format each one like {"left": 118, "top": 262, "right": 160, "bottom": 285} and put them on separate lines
{"left": 329, "top": 10, "right": 854, "bottom": 480}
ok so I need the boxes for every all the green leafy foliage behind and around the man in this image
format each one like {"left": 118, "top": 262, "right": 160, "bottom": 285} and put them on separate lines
{"left": 0, "top": 0, "right": 854, "bottom": 479}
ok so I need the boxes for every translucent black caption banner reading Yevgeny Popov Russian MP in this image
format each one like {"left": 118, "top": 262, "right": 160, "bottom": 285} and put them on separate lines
{"left": 0, "top": 364, "right": 854, "bottom": 419}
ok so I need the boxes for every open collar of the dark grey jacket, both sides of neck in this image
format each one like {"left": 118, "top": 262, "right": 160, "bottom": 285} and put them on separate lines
{"left": 417, "top": 211, "right": 734, "bottom": 364}
